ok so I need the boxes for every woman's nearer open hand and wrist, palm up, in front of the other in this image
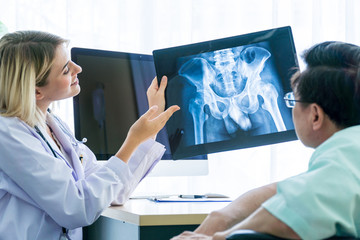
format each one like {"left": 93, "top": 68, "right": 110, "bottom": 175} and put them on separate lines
{"left": 115, "top": 105, "right": 180, "bottom": 163}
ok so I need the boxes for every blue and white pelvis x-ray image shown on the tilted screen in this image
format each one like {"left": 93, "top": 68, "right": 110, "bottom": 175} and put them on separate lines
{"left": 167, "top": 42, "right": 292, "bottom": 145}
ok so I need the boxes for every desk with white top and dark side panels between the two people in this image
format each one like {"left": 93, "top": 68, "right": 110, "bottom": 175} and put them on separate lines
{"left": 84, "top": 199, "right": 229, "bottom": 240}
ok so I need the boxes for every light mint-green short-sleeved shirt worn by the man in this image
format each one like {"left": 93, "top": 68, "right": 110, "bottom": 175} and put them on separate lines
{"left": 262, "top": 125, "right": 360, "bottom": 239}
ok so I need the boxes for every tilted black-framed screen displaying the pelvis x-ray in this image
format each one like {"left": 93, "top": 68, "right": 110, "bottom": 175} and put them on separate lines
{"left": 153, "top": 27, "right": 298, "bottom": 159}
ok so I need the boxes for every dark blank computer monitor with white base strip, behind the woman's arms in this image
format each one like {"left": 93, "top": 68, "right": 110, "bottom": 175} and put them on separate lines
{"left": 71, "top": 47, "right": 208, "bottom": 176}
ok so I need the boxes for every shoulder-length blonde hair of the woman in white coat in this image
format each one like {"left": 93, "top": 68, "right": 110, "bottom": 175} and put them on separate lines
{"left": 0, "top": 31, "right": 68, "bottom": 127}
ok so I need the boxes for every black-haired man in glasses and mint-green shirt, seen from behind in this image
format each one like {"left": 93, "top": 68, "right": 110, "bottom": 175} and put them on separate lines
{"left": 173, "top": 42, "right": 360, "bottom": 240}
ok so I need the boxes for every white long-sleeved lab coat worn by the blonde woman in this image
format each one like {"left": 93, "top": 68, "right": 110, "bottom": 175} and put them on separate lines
{"left": 0, "top": 114, "right": 165, "bottom": 240}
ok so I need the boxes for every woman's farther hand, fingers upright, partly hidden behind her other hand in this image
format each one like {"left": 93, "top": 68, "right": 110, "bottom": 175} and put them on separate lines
{"left": 146, "top": 76, "right": 167, "bottom": 116}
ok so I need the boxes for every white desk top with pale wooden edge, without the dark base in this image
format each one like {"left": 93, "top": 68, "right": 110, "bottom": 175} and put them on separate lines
{"left": 102, "top": 199, "right": 229, "bottom": 226}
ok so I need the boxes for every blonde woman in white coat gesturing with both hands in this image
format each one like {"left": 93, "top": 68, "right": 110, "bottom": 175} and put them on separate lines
{"left": 0, "top": 31, "right": 179, "bottom": 240}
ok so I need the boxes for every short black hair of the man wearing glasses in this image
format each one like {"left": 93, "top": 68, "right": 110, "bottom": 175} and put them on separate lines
{"left": 291, "top": 42, "right": 360, "bottom": 128}
